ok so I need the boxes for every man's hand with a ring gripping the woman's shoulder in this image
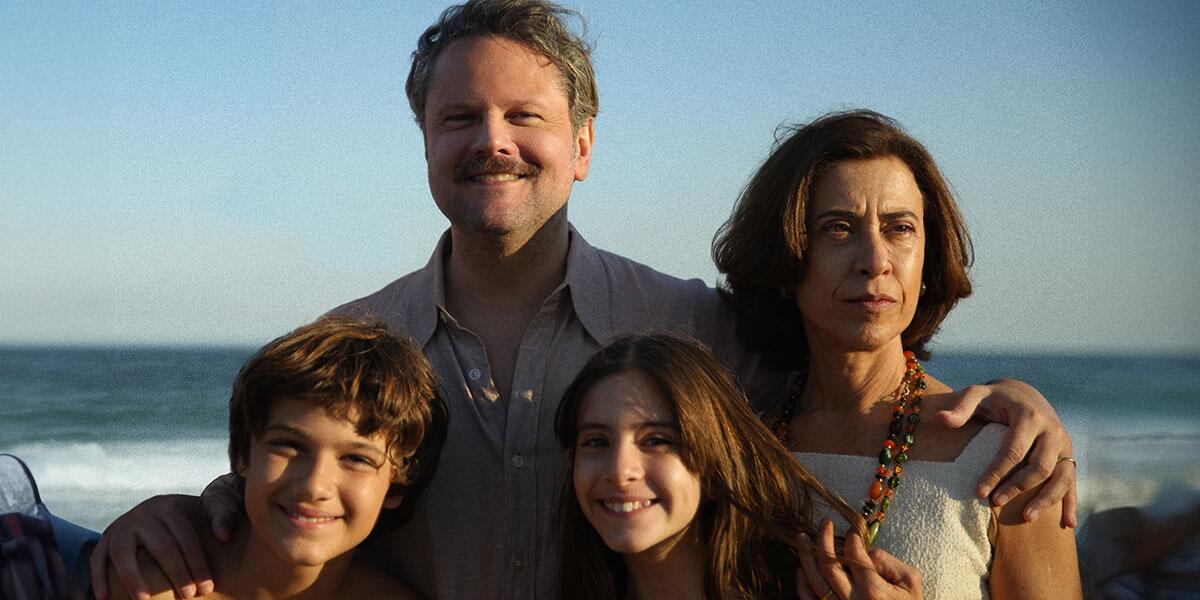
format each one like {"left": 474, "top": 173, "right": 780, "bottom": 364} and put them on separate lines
{"left": 938, "top": 379, "right": 1076, "bottom": 527}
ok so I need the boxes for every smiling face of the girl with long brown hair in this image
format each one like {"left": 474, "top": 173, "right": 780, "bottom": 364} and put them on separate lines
{"left": 572, "top": 371, "right": 702, "bottom": 554}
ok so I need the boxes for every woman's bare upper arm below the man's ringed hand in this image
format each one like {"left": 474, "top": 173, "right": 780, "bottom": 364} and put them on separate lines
{"left": 988, "top": 488, "right": 1084, "bottom": 600}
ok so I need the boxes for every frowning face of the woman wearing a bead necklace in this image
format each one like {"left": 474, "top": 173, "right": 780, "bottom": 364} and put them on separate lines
{"left": 793, "top": 156, "right": 925, "bottom": 352}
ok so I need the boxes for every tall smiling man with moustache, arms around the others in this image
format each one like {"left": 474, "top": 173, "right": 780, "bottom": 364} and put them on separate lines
{"left": 92, "top": 0, "right": 1074, "bottom": 599}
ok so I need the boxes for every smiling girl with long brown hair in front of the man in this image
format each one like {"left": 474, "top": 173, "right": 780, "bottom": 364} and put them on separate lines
{"left": 556, "top": 335, "right": 920, "bottom": 600}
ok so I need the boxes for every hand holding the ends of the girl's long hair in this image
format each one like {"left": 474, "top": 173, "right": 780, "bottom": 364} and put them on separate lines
{"left": 796, "top": 520, "right": 922, "bottom": 600}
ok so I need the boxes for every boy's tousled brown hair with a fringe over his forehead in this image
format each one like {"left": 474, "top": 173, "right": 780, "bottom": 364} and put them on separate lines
{"left": 229, "top": 316, "right": 446, "bottom": 532}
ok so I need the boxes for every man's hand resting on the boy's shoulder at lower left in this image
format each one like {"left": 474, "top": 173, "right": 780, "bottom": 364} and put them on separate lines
{"left": 89, "top": 474, "right": 240, "bottom": 600}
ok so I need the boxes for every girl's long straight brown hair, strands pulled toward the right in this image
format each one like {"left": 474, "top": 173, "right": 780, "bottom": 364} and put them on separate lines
{"left": 556, "top": 334, "right": 863, "bottom": 600}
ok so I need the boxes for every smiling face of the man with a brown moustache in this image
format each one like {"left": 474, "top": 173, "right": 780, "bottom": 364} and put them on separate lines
{"left": 422, "top": 36, "right": 592, "bottom": 244}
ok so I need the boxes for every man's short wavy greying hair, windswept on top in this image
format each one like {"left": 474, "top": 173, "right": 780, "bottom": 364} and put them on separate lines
{"left": 404, "top": 0, "right": 600, "bottom": 131}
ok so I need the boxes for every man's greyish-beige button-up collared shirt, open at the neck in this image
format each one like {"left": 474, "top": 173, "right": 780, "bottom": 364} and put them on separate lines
{"left": 334, "top": 228, "right": 762, "bottom": 600}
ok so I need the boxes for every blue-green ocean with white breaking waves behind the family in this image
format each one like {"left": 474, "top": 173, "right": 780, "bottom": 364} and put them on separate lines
{"left": 0, "top": 348, "right": 1200, "bottom": 530}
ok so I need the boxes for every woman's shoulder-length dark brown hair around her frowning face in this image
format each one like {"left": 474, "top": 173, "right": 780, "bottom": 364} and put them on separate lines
{"left": 713, "top": 110, "right": 973, "bottom": 367}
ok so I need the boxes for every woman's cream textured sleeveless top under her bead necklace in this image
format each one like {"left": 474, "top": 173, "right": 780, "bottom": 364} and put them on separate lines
{"left": 793, "top": 424, "right": 1004, "bottom": 599}
